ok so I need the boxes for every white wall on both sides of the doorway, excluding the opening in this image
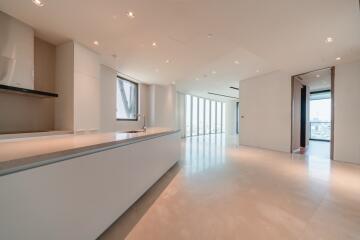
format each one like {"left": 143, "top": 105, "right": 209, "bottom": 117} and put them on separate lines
{"left": 240, "top": 61, "right": 360, "bottom": 164}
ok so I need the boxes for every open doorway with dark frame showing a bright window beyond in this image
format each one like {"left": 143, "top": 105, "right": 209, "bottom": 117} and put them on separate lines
{"left": 290, "top": 67, "right": 335, "bottom": 159}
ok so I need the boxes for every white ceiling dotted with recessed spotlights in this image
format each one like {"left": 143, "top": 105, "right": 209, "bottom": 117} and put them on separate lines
{"left": 0, "top": 0, "right": 360, "bottom": 101}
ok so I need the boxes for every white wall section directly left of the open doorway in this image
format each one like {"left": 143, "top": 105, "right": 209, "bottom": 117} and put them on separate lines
{"left": 239, "top": 71, "right": 291, "bottom": 152}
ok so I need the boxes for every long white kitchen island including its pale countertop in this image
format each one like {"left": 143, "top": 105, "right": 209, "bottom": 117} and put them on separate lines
{"left": 0, "top": 128, "right": 180, "bottom": 239}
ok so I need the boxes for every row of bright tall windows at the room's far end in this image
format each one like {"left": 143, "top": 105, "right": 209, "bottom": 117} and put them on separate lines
{"left": 185, "top": 95, "right": 225, "bottom": 137}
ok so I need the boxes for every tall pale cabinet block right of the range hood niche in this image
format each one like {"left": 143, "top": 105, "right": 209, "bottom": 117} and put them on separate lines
{"left": 55, "top": 41, "right": 100, "bottom": 132}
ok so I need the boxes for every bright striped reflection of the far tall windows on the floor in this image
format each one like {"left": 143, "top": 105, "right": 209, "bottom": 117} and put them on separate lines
{"left": 184, "top": 134, "right": 226, "bottom": 175}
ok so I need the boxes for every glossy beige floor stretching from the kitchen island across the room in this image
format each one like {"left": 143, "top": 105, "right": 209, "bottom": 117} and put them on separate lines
{"left": 99, "top": 135, "right": 360, "bottom": 240}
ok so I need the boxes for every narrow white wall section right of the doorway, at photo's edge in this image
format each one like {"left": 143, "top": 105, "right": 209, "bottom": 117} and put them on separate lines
{"left": 334, "top": 61, "right": 360, "bottom": 164}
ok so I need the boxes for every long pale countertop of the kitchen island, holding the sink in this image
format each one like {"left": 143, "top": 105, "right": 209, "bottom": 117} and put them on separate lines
{"left": 0, "top": 128, "right": 177, "bottom": 176}
